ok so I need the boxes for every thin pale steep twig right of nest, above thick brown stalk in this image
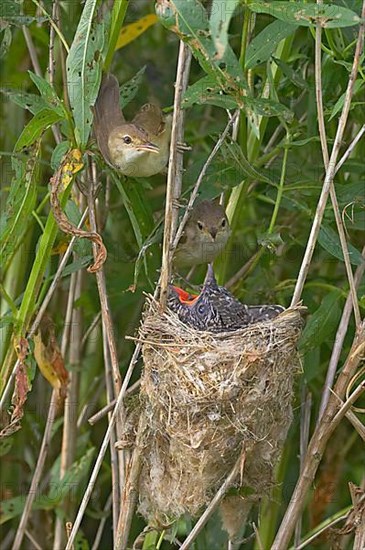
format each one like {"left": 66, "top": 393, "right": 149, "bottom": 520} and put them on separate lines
{"left": 318, "top": 246, "right": 365, "bottom": 422}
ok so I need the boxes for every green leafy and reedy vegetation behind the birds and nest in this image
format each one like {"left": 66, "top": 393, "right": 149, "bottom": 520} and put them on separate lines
{"left": 0, "top": 0, "right": 365, "bottom": 549}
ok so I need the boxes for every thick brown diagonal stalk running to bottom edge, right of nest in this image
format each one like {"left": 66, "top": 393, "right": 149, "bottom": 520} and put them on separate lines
{"left": 271, "top": 322, "right": 365, "bottom": 550}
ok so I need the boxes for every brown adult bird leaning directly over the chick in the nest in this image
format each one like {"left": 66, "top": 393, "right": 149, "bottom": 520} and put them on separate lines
{"left": 174, "top": 200, "right": 231, "bottom": 267}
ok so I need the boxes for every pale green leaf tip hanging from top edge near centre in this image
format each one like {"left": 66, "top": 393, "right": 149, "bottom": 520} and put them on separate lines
{"left": 209, "top": 0, "right": 240, "bottom": 59}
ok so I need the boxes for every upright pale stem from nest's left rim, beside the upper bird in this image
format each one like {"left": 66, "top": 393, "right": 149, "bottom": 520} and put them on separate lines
{"left": 160, "top": 41, "right": 191, "bottom": 309}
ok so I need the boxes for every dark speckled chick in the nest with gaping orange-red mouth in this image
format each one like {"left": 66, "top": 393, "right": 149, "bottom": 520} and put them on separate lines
{"left": 167, "top": 264, "right": 284, "bottom": 332}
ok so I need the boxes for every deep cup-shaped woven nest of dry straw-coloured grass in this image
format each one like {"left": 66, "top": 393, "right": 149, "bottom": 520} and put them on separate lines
{"left": 138, "top": 301, "right": 302, "bottom": 525}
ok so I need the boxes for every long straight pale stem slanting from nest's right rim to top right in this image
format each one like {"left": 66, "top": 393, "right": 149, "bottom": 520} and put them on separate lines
{"left": 292, "top": 0, "right": 365, "bottom": 305}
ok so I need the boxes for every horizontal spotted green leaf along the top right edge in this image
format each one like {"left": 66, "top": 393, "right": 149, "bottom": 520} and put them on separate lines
{"left": 249, "top": 1, "right": 361, "bottom": 29}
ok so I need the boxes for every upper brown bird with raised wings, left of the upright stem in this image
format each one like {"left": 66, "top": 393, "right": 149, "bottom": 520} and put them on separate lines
{"left": 94, "top": 74, "right": 171, "bottom": 178}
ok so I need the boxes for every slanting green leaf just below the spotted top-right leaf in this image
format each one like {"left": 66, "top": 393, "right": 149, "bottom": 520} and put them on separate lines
{"left": 245, "top": 21, "right": 297, "bottom": 69}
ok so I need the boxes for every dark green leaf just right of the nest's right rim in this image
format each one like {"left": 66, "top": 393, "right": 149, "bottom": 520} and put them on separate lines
{"left": 299, "top": 296, "right": 341, "bottom": 353}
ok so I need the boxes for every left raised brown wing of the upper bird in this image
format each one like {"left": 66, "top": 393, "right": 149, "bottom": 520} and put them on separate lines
{"left": 93, "top": 74, "right": 125, "bottom": 163}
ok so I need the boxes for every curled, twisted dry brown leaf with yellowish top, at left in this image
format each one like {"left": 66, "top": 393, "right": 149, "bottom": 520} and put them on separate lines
{"left": 51, "top": 149, "right": 107, "bottom": 273}
